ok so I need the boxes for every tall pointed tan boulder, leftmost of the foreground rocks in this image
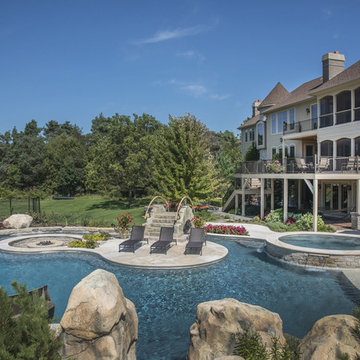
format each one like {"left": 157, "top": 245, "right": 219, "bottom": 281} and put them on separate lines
{"left": 60, "top": 269, "right": 138, "bottom": 360}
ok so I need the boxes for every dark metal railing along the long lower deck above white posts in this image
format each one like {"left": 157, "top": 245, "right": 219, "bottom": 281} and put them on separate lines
{"left": 236, "top": 156, "right": 360, "bottom": 174}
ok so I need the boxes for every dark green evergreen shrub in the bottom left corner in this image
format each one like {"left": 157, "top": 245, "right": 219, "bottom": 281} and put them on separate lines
{"left": 0, "top": 281, "right": 61, "bottom": 360}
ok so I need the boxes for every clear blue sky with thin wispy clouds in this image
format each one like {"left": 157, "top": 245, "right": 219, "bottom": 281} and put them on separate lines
{"left": 0, "top": 0, "right": 360, "bottom": 132}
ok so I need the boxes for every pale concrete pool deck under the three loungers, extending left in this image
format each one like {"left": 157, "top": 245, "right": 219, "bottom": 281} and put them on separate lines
{"left": 0, "top": 232, "right": 228, "bottom": 269}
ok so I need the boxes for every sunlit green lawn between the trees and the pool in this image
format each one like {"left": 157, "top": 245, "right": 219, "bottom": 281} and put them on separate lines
{"left": 41, "top": 196, "right": 150, "bottom": 227}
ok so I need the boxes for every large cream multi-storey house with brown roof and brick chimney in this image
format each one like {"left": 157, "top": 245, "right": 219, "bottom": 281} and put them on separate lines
{"left": 224, "top": 51, "right": 360, "bottom": 231}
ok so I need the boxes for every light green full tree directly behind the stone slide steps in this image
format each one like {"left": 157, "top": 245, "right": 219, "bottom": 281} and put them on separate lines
{"left": 154, "top": 114, "right": 217, "bottom": 200}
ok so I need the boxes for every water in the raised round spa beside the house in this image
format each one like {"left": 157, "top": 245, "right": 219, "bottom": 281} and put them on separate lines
{"left": 279, "top": 234, "right": 360, "bottom": 250}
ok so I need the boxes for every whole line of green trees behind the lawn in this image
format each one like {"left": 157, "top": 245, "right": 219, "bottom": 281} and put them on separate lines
{"left": 0, "top": 114, "right": 241, "bottom": 200}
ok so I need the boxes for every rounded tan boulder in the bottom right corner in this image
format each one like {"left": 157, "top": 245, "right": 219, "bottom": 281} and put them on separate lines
{"left": 300, "top": 315, "right": 360, "bottom": 360}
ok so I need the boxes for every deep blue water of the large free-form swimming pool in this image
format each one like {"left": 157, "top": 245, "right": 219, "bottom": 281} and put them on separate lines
{"left": 0, "top": 237, "right": 355, "bottom": 360}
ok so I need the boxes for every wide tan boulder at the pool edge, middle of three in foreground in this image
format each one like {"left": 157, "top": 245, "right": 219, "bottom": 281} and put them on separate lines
{"left": 188, "top": 299, "right": 285, "bottom": 360}
